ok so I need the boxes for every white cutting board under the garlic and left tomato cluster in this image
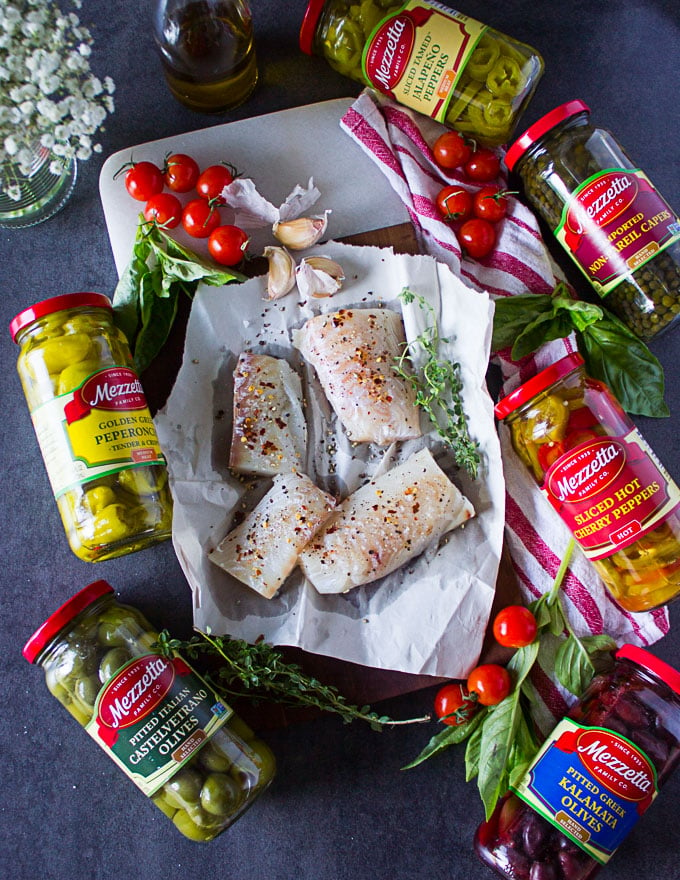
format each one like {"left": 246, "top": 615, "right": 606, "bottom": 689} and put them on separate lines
{"left": 99, "top": 98, "right": 409, "bottom": 275}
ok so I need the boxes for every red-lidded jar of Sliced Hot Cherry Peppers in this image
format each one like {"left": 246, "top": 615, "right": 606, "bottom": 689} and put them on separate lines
{"left": 495, "top": 353, "right": 680, "bottom": 611}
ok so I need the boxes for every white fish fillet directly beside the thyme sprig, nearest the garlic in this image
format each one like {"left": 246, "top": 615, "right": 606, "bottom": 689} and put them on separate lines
{"left": 293, "top": 309, "right": 422, "bottom": 446}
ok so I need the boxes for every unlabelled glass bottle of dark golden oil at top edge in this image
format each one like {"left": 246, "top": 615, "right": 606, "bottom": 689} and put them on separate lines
{"left": 152, "top": 0, "right": 258, "bottom": 113}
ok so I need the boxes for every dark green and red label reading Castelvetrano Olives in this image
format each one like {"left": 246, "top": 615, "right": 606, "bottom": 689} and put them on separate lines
{"left": 86, "top": 654, "right": 232, "bottom": 796}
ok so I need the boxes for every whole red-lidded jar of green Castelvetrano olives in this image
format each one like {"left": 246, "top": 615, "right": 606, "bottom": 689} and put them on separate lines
{"left": 23, "top": 581, "right": 275, "bottom": 841}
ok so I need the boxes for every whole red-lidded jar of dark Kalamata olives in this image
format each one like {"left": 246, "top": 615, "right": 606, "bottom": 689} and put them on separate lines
{"left": 475, "top": 645, "right": 680, "bottom": 880}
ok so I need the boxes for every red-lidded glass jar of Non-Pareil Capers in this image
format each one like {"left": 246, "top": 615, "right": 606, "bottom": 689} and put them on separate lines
{"left": 506, "top": 101, "right": 680, "bottom": 341}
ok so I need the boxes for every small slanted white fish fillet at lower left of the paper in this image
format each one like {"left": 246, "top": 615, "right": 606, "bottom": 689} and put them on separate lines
{"left": 208, "top": 473, "right": 335, "bottom": 599}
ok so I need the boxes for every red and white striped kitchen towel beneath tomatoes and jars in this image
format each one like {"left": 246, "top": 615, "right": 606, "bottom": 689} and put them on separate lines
{"left": 341, "top": 89, "right": 669, "bottom": 714}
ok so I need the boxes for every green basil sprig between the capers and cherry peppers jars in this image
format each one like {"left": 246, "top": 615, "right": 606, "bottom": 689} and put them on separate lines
{"left": 492, "top": 283, "right": 669, "bottom": 418}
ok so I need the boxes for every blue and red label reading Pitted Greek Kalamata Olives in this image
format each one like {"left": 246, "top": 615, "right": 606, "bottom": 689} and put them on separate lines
{"left": 513, "top": 718, "right": 658, "bottom": 864}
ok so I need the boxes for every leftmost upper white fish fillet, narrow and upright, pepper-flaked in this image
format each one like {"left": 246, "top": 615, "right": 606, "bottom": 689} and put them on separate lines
{"left": 229, "top": 352, "right": 307, "bottom": 476}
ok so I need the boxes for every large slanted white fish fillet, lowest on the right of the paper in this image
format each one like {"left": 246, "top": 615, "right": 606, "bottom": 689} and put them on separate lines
{"left": 299, "top": 449, "right": 475, "bottom": 593}
